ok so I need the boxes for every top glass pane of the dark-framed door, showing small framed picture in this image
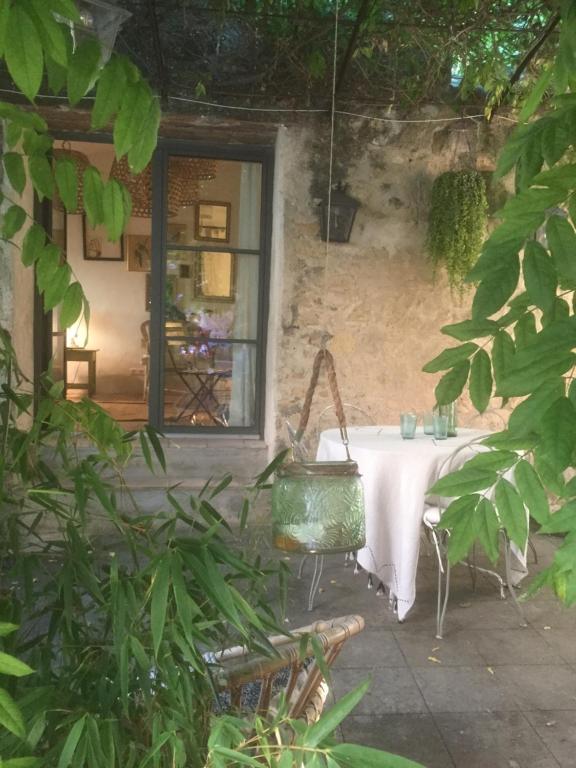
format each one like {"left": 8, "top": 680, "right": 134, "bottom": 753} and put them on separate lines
{"left": 167, "top": 156, "right": 262, "bottom": 250}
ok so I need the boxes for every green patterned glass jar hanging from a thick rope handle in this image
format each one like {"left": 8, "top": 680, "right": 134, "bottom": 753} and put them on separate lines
{"left": 272, "top": 461, "right": 366, "bottom": 554}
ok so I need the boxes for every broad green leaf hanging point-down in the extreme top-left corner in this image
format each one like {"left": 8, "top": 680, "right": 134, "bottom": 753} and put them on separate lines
{"left": 5, "top": 3, "right": 44, "bottom": 101}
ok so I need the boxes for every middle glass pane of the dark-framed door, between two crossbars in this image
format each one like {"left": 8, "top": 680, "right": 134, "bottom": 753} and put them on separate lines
{"left": 165, "top": 250, "right": 259, "bottom": 339}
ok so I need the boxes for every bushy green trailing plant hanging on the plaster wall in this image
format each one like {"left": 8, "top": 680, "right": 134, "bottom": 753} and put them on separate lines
{"left": 428, "top": 171, "right": 488, "bottom": 294}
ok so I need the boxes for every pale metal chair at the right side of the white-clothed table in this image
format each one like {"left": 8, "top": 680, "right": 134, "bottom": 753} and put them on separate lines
{"left": 423, "top": 435, "right": 526, "bottom": 640}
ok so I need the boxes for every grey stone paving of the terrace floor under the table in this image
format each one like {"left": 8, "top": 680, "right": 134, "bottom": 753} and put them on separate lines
{"left": 280, "top": 537, "right": 576, "bottom": 768}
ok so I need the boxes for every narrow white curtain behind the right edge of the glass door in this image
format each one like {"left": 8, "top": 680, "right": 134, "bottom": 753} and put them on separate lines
{"left": 230, "top": 163, "right": 262, "bottom": 427}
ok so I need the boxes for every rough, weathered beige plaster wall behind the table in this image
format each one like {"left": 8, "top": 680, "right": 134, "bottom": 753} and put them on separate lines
{"left": 271, "top": 113, "right": 510, "bottom": 450}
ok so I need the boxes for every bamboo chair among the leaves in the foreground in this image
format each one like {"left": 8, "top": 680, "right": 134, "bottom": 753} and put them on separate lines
{"left": 214, "top": 616, "right": 364, "bottom": 724}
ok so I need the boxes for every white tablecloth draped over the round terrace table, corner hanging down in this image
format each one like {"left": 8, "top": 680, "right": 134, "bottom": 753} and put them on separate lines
{"left": 317, "top": 426, "right": 486, "bottom": 620}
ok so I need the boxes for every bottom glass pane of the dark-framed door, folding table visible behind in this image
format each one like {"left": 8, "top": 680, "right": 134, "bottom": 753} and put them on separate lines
{"left": 164, "top": 344, "right": 256, "bottom": 427}
